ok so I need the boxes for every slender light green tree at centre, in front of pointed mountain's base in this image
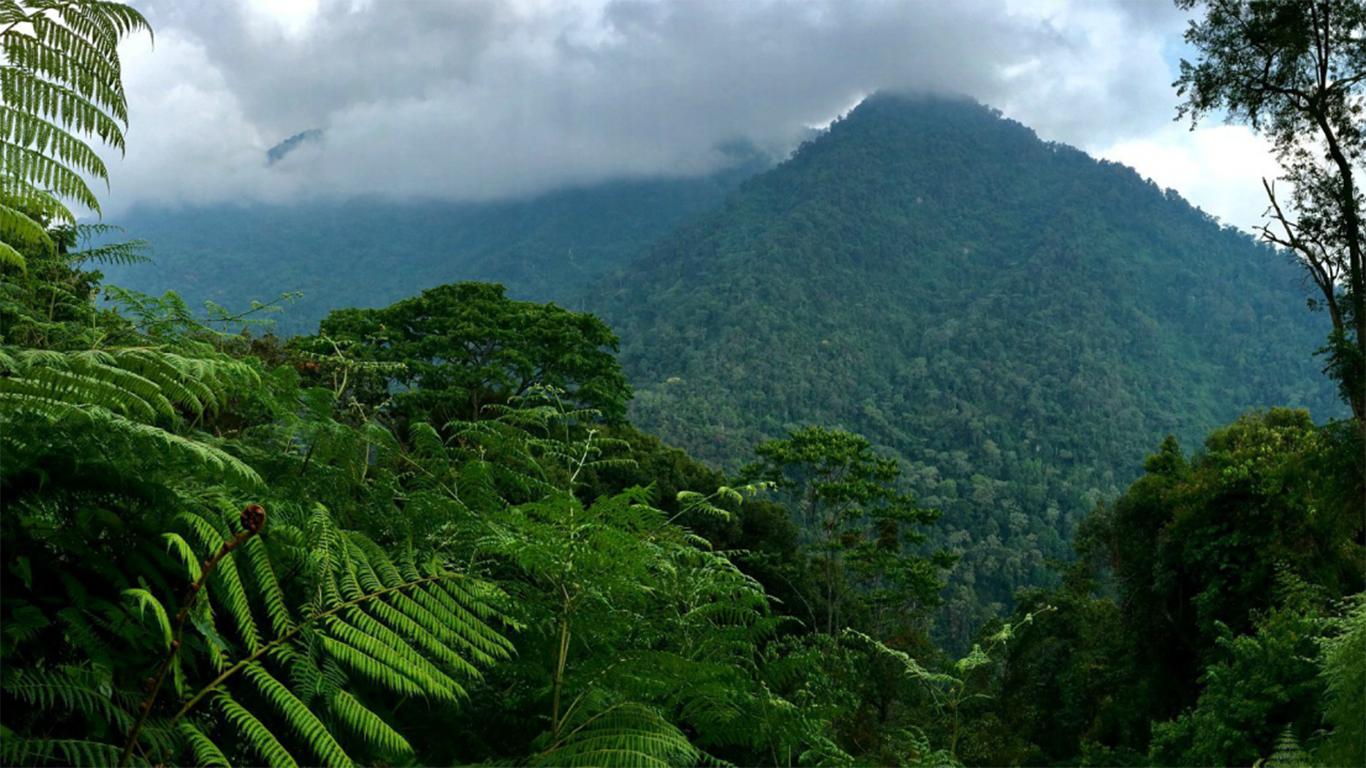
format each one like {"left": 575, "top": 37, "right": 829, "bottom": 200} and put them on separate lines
{"left": 740, "top": 426, "right": 952, "bottom": 637}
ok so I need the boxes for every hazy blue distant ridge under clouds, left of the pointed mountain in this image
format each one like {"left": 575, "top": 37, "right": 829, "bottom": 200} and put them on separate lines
{"left": 107, "top": 148, "right": 772, "bottom": 333}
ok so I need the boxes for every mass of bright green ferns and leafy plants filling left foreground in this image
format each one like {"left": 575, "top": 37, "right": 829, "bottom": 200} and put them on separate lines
{"left": 0, "top": 206, "right": 841, "bottom": 765}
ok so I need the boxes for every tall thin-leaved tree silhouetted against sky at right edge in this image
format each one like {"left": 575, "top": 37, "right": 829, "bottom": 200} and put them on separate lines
{"left": 1175, "top": 0, "right": 1366, "bottom": 430}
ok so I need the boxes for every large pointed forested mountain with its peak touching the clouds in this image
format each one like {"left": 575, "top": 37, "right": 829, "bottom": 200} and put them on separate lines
{"left": 587, "top": 90, "right": 1341, "bottom": 642}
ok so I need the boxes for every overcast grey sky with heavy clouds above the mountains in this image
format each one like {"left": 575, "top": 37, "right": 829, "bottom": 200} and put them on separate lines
{"left": 107, "top": 0, "right": 1274, "bottom": 228}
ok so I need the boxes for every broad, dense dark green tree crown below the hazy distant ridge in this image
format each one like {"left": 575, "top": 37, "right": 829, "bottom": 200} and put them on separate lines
{"left": 299, "top": 283, "right": 631, "bottom": 426}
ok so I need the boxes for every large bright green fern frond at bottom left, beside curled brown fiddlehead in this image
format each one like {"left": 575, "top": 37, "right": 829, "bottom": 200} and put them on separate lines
{"left": 158, "top": 507, "right": 512, "bottom": 765}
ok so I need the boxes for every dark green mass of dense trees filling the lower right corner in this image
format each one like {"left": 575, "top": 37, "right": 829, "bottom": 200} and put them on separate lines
{"left": 968, "top": 410, "right": 1366, "bottom": 765}
